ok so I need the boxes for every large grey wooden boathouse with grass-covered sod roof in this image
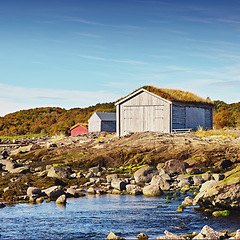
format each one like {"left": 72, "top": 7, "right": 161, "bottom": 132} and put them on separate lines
{"left": 116, "top": 86, "right": 213, "bottom": 136}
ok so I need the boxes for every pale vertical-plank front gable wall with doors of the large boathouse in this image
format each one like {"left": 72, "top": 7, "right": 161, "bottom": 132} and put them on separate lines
{"left": 117, "top": 91, "right": 171, "bottom": 135}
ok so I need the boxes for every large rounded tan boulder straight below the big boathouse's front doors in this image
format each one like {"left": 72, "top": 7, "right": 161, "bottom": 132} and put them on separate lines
{"left": 134, "top": 167, "right": 159, "bottom": 183}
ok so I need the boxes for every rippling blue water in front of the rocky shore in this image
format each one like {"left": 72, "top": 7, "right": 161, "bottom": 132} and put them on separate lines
{"left": 0, "top": 195, "right": 240, "bottom": 239}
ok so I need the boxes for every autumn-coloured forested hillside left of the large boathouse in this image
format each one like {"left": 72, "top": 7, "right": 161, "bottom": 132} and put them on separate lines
{"left": 0, "top": 103, "right": 115, "bottom": 136}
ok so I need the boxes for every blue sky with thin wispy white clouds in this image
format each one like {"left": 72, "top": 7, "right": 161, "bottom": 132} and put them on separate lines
{"left": 0, "top": 0, "right": 240, "bottom": 116}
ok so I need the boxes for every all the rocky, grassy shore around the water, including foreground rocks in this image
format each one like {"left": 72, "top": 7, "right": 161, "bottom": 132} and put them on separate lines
{"left": 0, "top": 129, "right": 240, "bottom": 239}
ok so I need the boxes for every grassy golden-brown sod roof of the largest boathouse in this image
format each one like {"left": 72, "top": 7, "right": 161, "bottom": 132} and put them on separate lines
{"left": 117, "top": 86, "right": 213, "bottom": 105}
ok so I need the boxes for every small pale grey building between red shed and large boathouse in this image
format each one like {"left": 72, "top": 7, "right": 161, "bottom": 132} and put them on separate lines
{"left": 88, "top": 112, "right": 116, "bottom": 132}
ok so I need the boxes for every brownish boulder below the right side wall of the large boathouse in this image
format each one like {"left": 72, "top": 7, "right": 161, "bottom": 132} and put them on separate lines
{"left": 163, "top": 159, "right": 189, "bottom": 174}
